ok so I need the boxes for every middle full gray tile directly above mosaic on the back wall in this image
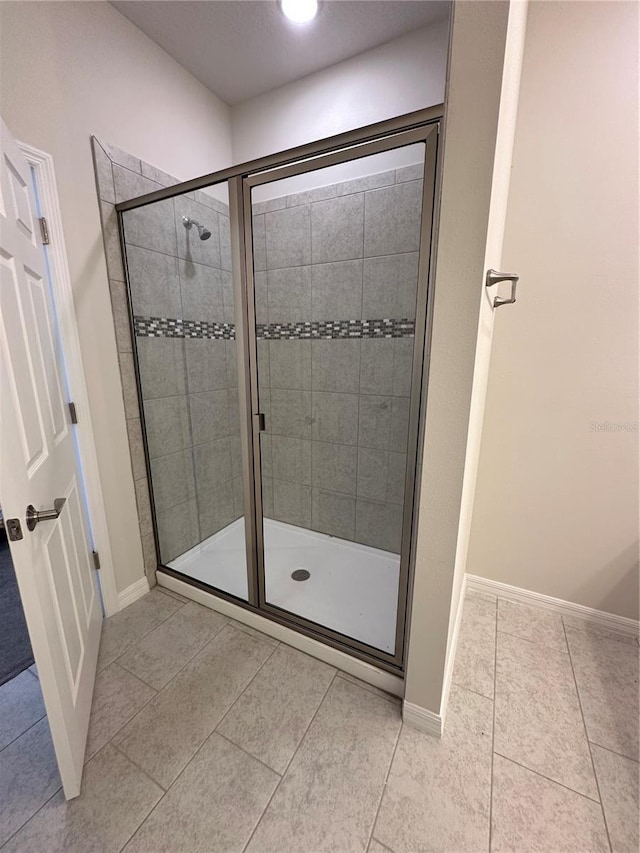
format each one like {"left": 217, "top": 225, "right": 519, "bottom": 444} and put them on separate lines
{"left": 312, "top": 259, "right": 362, "bottom": 320}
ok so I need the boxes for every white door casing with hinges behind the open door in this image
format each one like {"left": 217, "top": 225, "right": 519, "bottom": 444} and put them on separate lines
{"left": 17, "top": 141, "right": 120, "bottom": 616}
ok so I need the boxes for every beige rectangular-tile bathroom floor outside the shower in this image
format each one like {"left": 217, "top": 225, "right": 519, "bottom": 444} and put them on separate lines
{"left": 0, "top": 588, "right": 640, "bottom": 853}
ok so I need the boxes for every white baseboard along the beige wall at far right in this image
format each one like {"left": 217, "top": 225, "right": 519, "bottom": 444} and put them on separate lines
{"left": 466, "top": 575, "right": 640, "bottom": 636}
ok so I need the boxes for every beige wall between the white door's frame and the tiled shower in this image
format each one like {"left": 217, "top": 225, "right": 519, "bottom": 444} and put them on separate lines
{"left": 0, "top": 2, "right": 231, "bottom": 592}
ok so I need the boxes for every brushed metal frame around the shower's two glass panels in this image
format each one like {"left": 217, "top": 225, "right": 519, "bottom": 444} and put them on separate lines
{"left": 115, "top": 104, "right": 444, "bottom": 678}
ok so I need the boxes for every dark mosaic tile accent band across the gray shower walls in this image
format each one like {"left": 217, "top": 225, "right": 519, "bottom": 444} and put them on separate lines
{"left": 133, "top": 317, "right": 415, "bottom": 341}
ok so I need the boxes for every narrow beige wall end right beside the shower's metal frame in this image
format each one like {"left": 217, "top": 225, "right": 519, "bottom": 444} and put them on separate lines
{"left": 405, "top": 0, "right": 509, "bottom": 714}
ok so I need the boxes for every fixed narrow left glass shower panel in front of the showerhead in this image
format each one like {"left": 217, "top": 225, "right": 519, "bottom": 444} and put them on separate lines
{"left": 122, "top": 181, "right": 248, "bottom": 601}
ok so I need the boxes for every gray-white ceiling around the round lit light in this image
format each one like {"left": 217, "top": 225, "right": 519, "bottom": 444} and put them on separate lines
{"left": 111, "top": 0, "right": 449, "bottom": 105}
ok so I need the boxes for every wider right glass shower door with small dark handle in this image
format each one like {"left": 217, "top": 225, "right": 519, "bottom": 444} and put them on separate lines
{"left": 245, "top": 129, "right": 435, "bottom": 660}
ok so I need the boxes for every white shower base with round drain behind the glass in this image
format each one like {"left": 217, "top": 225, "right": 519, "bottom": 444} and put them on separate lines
{"left": 168, "top": 518, "right": 400, "bottom": 654}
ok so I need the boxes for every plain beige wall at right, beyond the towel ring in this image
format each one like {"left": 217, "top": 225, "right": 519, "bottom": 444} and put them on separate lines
{"left": 467, "top": 2, "right": 639, "bottom": 619}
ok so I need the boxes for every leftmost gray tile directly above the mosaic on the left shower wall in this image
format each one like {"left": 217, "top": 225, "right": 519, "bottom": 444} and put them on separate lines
{"left": 127, "top": 246, "right": 182, "bottom": 318}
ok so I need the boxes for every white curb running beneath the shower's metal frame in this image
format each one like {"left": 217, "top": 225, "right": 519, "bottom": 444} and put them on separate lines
{"left": 157, "top": 572, "right": 404, "bottom": 697}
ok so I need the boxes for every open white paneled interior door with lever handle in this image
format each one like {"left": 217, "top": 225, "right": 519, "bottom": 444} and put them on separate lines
{"left": 0, "top": 116, "right": 102, "bottom": 799}
